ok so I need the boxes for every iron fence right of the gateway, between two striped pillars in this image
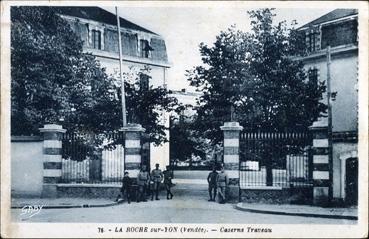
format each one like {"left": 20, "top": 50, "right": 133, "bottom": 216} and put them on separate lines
{"left": 240, "top": 132, "right": 312, "bottom": 188}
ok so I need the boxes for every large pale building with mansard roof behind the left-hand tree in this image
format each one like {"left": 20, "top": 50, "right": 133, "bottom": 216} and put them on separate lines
{"left": 57, "top": 7, "right": 170, "bottom": 171}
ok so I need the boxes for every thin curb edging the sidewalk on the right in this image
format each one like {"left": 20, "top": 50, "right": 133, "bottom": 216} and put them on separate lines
{"left": 235, "top": 204, "right": 358, "bottom": 220}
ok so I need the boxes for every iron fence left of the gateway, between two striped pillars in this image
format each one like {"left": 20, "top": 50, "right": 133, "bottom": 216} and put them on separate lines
{"left": 61, "top": 132, "right": 124, "bottom": 183}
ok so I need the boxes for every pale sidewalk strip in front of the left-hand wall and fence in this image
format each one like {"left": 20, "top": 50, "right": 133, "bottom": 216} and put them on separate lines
{"left": 11, "top": 198, "right": 118, "bottom": 209}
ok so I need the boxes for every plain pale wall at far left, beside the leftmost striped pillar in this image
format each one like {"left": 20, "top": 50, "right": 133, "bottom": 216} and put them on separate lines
{"left": 11, "top": 137, "right": 43, "bottom": 197}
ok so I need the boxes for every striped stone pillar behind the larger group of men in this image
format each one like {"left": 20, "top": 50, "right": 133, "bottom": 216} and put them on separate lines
{"left": 122, "top": 124, "right": 145, "bottom": 178}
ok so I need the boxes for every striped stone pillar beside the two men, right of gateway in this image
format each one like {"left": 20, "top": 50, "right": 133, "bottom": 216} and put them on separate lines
{"left": 220, "top": 122, "right": 243, "bottom": 200}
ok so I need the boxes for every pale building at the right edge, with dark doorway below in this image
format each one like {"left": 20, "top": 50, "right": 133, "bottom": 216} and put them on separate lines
{"left": 299, "top": 9, "right": 358, "bottom": 204}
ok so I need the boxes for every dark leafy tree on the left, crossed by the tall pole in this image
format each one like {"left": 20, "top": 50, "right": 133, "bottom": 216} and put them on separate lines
{"left": 11, "top": 7, "right": 176, "bottom": 156}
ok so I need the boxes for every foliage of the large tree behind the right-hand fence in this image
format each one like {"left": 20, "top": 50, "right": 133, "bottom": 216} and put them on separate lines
{"left": 188, "top": 9, "right": 326, "bottom": 144}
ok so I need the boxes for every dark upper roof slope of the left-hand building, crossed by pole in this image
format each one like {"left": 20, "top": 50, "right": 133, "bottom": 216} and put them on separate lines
{"left": 55, "top": 7, "right": 158, "bottom": 35}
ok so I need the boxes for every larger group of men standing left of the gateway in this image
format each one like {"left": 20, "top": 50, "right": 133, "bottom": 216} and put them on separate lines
{"left": 115, "top": 164, "right": 173, "bottom": 203}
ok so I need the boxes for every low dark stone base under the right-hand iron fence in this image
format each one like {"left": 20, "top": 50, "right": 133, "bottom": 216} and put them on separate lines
{"left": 240, "top": 188, "right": 313, "bottom": 205}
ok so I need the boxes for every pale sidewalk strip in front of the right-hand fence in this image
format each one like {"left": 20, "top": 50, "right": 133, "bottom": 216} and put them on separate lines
{"left": 235, "top": 202, "right": 358, "bottom": 220}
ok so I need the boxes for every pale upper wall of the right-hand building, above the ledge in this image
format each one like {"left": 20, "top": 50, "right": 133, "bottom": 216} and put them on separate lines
{"left": 305, "top": 51, "right": 358, "bottom": 132}
